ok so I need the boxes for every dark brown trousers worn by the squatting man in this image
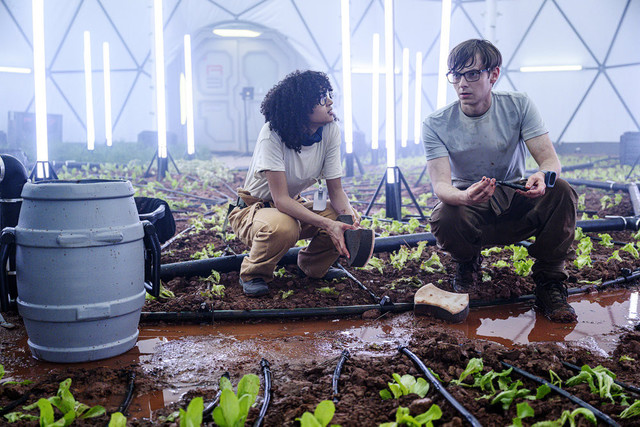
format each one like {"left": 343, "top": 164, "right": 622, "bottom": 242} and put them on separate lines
{"left": 430, "top": 179, "right": 578, "bottom": 282}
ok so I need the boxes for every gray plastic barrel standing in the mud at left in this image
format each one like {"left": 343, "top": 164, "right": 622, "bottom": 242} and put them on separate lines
{"left": 10, "top": 180, "right": 145, "bottom": 363}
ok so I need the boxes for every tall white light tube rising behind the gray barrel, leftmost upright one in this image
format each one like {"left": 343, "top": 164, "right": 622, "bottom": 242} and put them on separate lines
{"left": 31, "top": 0, "right": 49, "bottom": 165}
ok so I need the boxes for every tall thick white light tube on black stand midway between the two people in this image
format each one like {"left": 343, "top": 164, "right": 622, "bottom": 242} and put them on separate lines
{"left": 384, "top": 0, "right": 396, "bottom": 184}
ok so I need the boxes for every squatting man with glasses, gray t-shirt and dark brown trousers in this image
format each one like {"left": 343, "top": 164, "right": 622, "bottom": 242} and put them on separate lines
{"left": 423, "top": 39, "right": 577, "bottom": 322}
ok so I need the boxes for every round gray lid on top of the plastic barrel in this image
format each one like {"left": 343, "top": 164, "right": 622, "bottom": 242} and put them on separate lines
{"left": 22, "top": 179, "right": 134, "bottom": 200}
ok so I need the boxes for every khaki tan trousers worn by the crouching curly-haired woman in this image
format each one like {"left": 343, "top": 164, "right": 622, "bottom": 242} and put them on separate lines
{"left": 229, "top": 190, "right": 338, "bottom": 282}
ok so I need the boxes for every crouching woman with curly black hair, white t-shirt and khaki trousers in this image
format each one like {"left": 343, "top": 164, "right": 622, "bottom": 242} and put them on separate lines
{"left": 229, "top": 71, "right": 373, "bottom": 297}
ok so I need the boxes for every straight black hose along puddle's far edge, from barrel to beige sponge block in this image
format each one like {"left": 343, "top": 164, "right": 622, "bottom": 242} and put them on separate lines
{"left": 140, "top": 304, "right": 413, "bottom": 323}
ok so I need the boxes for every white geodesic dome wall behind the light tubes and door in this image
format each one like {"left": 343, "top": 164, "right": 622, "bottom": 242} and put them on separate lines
{"left": 0, "top": 0, "right": 640, "bottom": 155}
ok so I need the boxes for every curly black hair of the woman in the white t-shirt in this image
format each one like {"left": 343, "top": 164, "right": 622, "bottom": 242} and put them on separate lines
{"left": 260, "top": 70, "right": 333, "bottom": 153}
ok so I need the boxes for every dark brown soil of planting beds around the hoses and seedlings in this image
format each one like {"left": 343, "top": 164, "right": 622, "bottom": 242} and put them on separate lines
{"left": 0, "top": 159, "right": 640, "bottom": 426}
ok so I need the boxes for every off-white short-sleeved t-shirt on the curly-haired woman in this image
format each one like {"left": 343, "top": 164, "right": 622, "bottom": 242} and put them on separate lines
{"left": 244, "top": 122, "right": 342, "bottom": 201}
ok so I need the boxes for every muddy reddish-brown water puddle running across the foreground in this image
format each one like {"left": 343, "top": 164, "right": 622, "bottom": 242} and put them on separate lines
{"left": 5, "top": 290, "right": 639, "bottom": 418}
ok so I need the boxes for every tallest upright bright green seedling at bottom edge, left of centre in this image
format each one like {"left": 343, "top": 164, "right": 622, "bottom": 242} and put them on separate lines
{"left": 211, "top": 374, "right": 260, "bottom": 427}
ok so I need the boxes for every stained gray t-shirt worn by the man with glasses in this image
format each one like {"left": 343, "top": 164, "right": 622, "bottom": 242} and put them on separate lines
{"left": 422, "top": 92, "right": 548, "bottom": 188}
